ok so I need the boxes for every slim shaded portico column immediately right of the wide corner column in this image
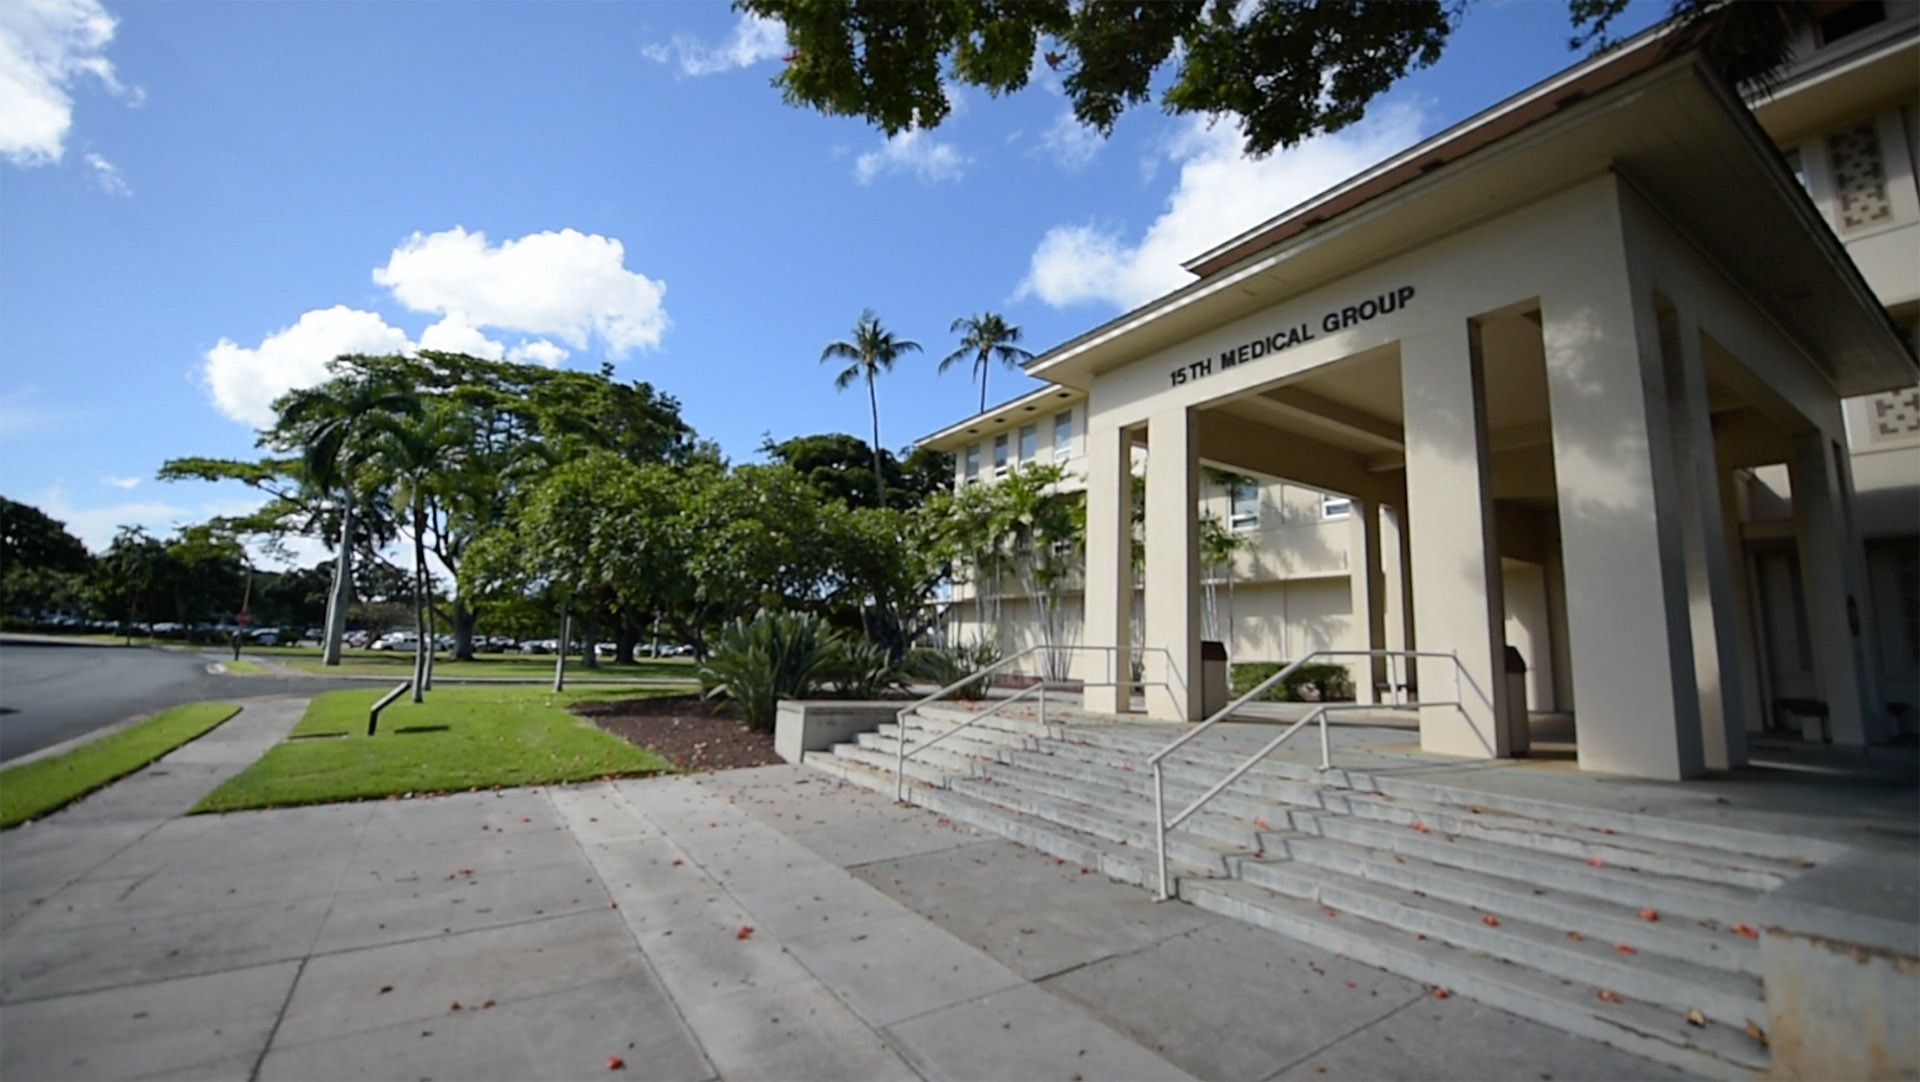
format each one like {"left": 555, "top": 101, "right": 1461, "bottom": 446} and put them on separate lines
{"left": 1661, "top": 311, "right": 1749, "bottom": 769}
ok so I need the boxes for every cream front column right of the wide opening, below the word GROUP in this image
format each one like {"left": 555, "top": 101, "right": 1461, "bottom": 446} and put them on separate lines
{"left": 1400, "top": 320, "right": 1507, "bottom": 758}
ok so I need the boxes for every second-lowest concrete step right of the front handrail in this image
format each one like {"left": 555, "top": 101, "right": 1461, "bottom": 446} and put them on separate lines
{"left": 1238, "top": 859, "right": 1766, "bottom": 1019}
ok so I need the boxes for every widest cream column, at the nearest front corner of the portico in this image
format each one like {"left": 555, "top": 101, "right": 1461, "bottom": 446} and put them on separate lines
{"left": 1540, "top": 270, "right": 1707, "bottom": 779}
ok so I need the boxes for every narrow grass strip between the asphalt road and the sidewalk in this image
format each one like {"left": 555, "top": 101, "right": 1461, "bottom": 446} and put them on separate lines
{"left": 0, "top": 702, "right": 240, "bottom": 829}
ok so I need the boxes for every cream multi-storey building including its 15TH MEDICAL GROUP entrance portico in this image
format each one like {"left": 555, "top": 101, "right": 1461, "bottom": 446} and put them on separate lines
{"left": 924, "top": 2, "right": 1920, "bottom": 777}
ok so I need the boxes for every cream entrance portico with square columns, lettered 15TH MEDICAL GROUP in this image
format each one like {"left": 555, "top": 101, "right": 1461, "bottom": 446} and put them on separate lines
{"left": 1052, "top": 59, "right": 1914, "bottom": 779}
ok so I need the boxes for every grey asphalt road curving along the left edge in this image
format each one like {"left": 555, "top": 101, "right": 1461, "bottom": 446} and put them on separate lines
{"left": 0, "top": 637, "right": 353, "bottom": 762}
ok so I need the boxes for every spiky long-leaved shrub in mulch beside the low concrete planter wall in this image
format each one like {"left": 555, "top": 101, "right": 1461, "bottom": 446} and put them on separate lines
{"left": 699, "top": 612, "right": 837, "bottom": 733}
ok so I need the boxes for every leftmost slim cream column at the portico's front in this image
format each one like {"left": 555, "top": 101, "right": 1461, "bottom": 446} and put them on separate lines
{"left": 1081, "top": 418, "right": 1133, "bottom": 714}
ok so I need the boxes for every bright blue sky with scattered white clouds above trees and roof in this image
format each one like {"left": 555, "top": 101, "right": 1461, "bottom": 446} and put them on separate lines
{"left": 0, "top": 0, "right": 1659, "bottom": 549}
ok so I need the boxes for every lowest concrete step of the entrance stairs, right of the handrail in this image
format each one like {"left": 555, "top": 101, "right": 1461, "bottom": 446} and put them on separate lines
{"left": 1181, "top": 879, "right": 1768, "bottom": 1076}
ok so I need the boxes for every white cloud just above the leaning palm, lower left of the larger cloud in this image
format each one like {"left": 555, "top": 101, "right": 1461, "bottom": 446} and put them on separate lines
{"left": 204, "top": 305, "right": 413, "bottom": 428}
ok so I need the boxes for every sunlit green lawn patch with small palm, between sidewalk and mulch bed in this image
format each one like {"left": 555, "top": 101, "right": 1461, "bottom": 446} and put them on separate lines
{"left": 194, "top": 687, "right": 674, "bottom": 813}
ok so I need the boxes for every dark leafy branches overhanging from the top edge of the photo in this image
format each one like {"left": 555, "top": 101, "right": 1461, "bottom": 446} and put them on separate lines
{"left": 733, "top": 0, "right": 1811, "bottom": 155}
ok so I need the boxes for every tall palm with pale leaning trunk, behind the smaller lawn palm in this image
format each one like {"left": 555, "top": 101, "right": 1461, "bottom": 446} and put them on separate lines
{"left": 267, "top": 357, "right": 420, "bottom": 666}
